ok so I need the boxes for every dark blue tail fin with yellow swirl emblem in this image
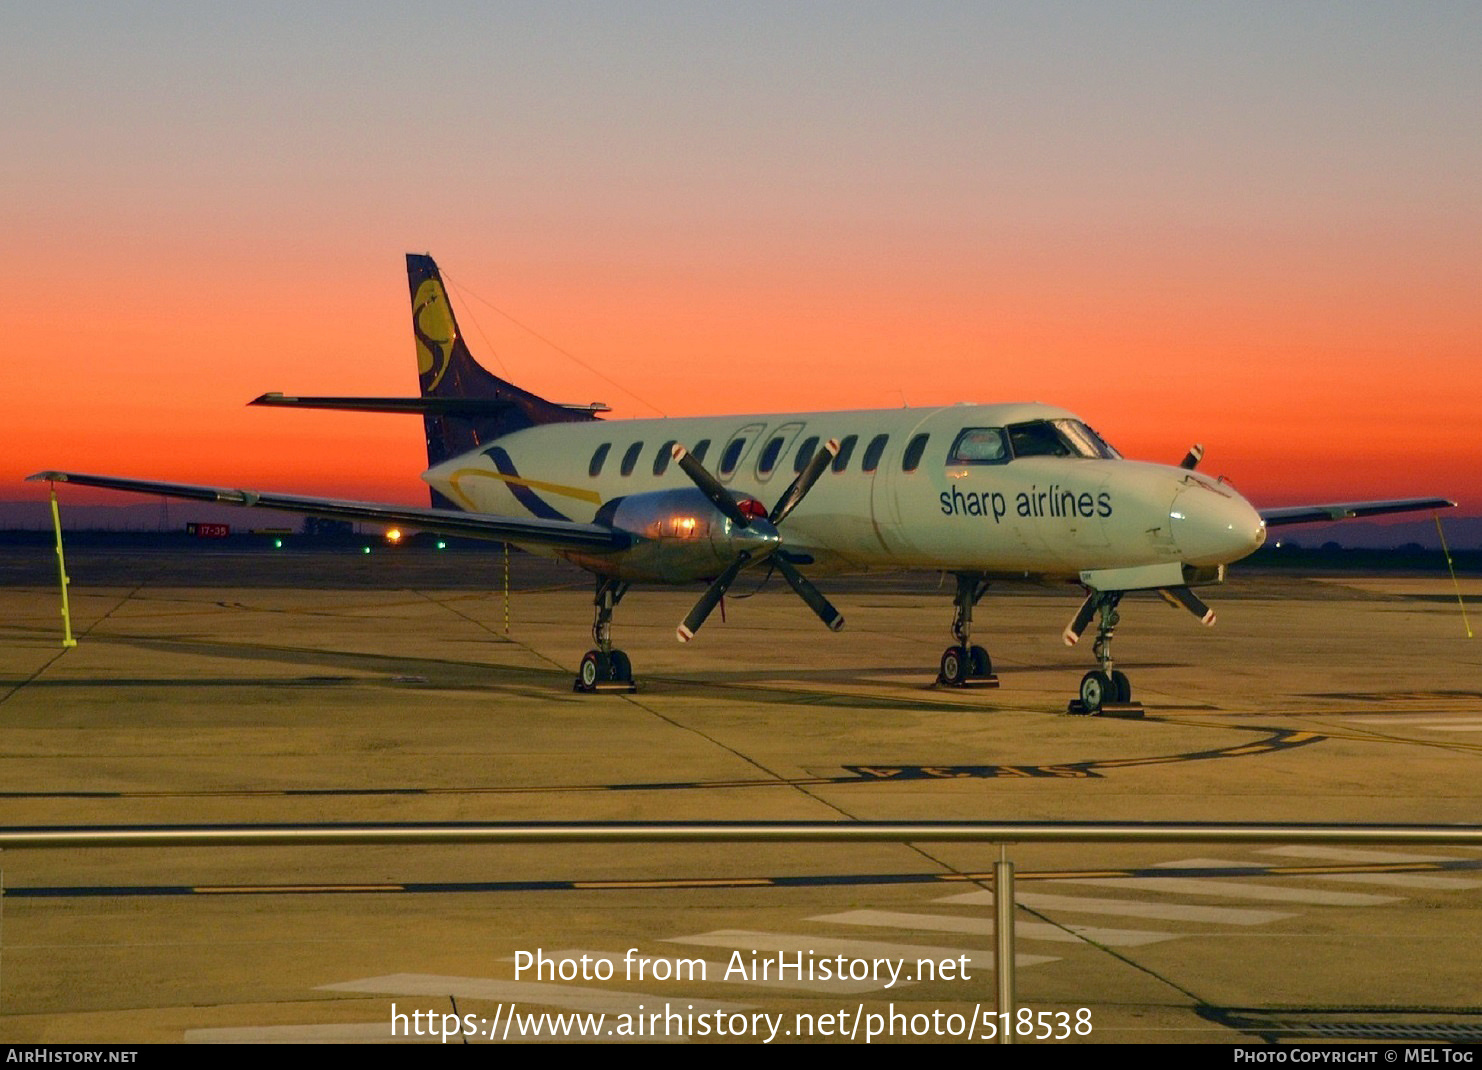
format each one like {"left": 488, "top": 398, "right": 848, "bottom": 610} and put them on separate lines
{"left": 406, "top": 253, "right": 596, "bottom": 468}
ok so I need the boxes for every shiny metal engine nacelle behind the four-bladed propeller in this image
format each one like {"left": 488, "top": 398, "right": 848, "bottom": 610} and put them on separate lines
{"left": 572, "top": 486, "right": 778, "bottom": 584}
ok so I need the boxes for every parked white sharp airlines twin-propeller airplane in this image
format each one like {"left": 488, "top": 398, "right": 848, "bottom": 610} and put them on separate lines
{"left": 28, "top": 253, "right": 1455, "bottom": 716}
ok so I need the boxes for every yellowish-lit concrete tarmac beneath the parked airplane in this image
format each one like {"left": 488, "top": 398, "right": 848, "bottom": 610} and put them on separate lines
{"left": 0, "top": 548, "right": 1482, "bottom": 1043}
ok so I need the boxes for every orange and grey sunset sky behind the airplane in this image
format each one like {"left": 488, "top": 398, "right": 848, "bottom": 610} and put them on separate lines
{"left": 0, "top": 0, "right": 1482, "bottom": 516}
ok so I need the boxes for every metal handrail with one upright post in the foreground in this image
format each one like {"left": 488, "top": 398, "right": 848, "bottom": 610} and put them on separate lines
{"left": 0, "top": 821, "right": 1482, "bottom": 1043}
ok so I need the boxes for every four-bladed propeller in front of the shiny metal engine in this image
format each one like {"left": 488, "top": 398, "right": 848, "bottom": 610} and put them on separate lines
{"left": 673, "top": 439, "right": 843, "bottom": 643}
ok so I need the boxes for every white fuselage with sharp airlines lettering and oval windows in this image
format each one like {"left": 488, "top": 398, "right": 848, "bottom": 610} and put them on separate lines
{"left": 422, "top": 403, "right": 1264, "bottom": 578}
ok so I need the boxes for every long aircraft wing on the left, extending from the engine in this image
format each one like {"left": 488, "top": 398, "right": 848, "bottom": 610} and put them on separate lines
{"left": 27, "top": 471, "right": 633, "bottom": 553}
